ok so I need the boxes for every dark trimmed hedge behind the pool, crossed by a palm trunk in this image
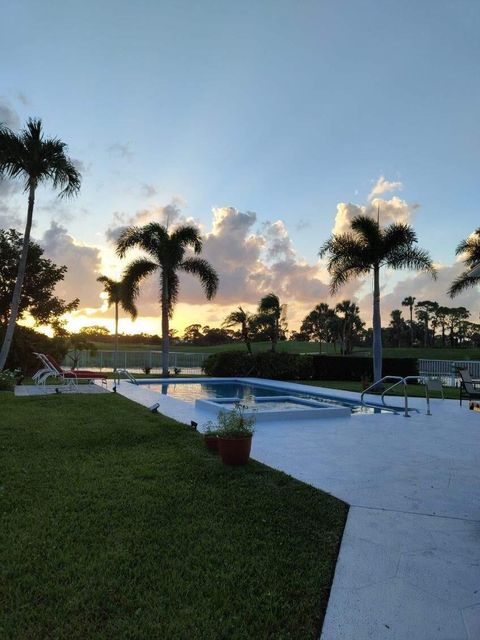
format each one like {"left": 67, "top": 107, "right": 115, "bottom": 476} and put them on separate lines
{"left": 203, "top": 351, "right": 418, "bottom": 381}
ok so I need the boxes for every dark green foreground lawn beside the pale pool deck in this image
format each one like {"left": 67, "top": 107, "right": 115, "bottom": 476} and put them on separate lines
{"left": 0, "top": 393, "right": 347, "bottom": 640}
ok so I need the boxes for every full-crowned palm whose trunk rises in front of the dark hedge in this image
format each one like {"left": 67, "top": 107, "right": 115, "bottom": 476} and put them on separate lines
{"left": 320, "top": 215, "right": 436, "bottom": 382}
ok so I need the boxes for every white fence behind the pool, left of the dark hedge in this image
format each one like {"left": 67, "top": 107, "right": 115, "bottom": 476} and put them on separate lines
{"left": 64, "top": 351, "right": 210, "bottom": 373}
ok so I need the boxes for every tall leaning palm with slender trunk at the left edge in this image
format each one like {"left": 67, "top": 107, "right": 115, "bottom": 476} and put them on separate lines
{"left": 0, "top": 119, "right": 81, "bottom": 371}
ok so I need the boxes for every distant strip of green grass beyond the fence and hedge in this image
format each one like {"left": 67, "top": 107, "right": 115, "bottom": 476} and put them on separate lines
{"left": 91, "top": 338, "right": 480, "bottom": 360}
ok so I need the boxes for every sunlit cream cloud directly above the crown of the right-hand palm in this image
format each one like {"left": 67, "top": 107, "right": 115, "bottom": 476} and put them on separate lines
{"left": 332, "top": 196, "right": 419, "bottom": 234}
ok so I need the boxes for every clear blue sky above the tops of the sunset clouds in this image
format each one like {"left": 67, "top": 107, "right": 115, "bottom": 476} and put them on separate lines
{"left": 0, "top": 0, "right": 480, "bottom": 330}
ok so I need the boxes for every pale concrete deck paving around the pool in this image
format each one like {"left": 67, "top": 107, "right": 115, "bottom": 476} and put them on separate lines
{"left": 109, "top": 379, "right": 480, "bottom": 640}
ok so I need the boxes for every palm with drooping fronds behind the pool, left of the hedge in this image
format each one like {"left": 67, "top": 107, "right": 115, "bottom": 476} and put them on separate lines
{"left": 117, "top": 222, "right": 218, "bottom": 376}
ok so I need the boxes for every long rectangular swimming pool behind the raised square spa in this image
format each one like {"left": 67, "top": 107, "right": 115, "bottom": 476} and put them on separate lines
{"left": 133, "top": 378, "right": 394, "bottom": 415}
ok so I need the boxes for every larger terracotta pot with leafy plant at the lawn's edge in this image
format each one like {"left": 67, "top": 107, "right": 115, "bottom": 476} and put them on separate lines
{"left": 216, "top": 402, "right": 255, "bottom": 465}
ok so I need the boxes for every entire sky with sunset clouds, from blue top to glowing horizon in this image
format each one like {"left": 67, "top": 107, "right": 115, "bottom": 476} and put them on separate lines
{"left": 0, "top": 0, "right": 480, "bottom": 333}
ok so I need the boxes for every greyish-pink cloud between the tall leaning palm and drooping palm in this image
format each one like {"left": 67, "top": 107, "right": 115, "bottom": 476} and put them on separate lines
{"left": 39, "top": 222, "right": 101, "bottom": 307}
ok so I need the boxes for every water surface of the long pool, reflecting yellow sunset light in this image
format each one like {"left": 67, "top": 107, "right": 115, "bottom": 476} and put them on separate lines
{"left": 142, "top": 380, "right": 391, "bottom": 414}
